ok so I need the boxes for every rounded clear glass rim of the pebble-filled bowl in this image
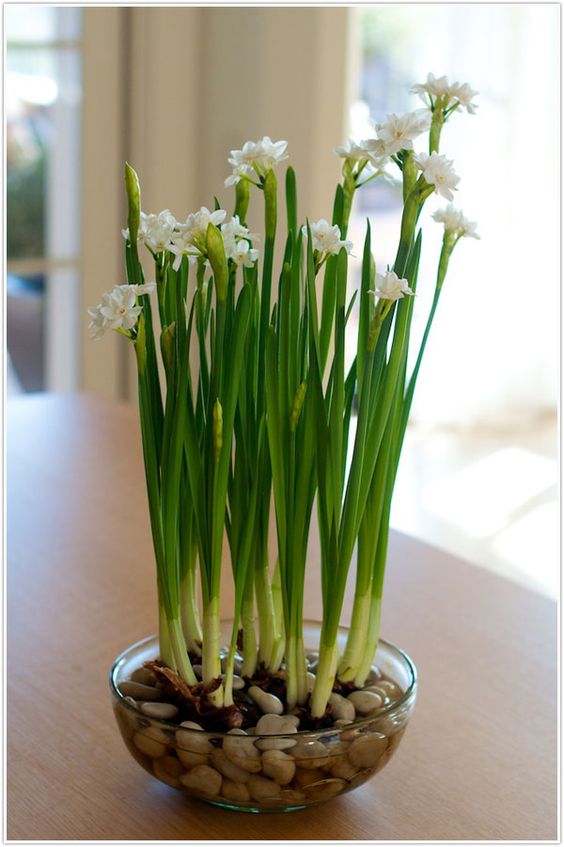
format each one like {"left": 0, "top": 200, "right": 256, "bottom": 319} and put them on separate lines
{"left": 109, "top": 620, "right": 418, "bottom": 739}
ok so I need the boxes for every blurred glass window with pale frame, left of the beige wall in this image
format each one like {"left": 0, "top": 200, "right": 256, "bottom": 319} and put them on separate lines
{"left": 5, "top": 5, "right": 82, "bottom": 392}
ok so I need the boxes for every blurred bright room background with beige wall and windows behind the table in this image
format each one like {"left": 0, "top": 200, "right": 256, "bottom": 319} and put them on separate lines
{"left": 4, "top": 3, "right": 560, "bottom": 596}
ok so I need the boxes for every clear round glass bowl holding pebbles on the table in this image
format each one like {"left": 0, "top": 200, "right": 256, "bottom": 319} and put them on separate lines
{"left": 110, "top": 621, "right": 417, "bottom": 812}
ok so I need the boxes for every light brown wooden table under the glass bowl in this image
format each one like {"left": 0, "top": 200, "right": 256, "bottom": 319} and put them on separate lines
{"left": 7, "top": 395, "right": 557, "bottom": 841}
